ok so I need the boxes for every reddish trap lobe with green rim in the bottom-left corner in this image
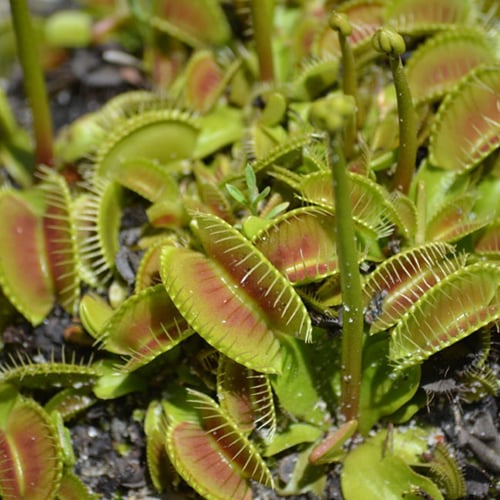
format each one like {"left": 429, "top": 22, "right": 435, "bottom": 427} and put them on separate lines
{"left": 0, "top": 399, "right": 63, "bottom": 500}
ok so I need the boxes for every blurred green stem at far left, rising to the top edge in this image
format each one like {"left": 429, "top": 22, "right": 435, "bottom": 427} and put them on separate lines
{"left": 10, "top": 0, "right": 54, "bottom": 165}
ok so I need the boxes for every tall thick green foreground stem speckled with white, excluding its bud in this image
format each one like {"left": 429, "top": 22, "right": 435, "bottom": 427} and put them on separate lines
{"left": 328, "top": 136, "right": 363, "bottom": 421}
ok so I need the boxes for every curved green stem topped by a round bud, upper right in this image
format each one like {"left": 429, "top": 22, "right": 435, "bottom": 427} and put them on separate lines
{"left": 373, "top": 27, "right": 417, "bottom": 194}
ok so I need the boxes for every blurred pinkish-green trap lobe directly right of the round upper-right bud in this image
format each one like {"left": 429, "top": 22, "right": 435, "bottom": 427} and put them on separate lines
{"left": 406, "top": 30, "right": 495, "bottom": 101}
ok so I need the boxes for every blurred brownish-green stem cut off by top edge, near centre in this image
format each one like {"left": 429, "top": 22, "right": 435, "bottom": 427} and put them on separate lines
{"left": 250, "top": 0, "right": 274, "bottom": 82}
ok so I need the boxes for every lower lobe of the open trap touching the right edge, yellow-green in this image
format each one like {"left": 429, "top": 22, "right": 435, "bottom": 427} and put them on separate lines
{"left": 389, "top": 262, "right": 500, "bottom": 369}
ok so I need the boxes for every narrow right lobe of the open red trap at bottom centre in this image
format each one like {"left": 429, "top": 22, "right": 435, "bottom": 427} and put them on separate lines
{"left": 188, "top": 390, "right": 273, "bottom": 487}
